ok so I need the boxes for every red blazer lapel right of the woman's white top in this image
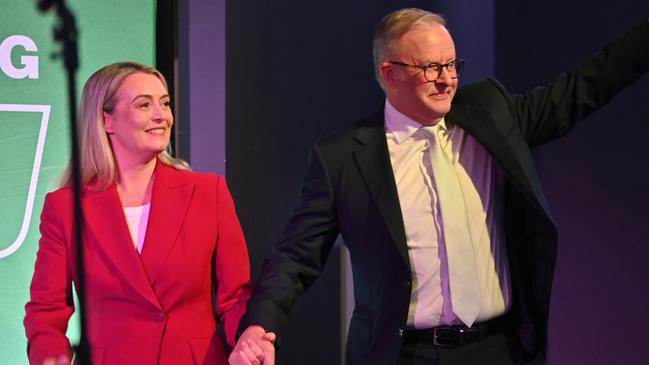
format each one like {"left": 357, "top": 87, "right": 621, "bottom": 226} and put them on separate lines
{"left": 140, "top": 161, "right": 194, "bottom": 285}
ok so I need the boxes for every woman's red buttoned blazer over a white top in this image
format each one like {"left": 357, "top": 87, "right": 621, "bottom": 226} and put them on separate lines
{"left": 24, "top": 162, "right": 250, "bottom": 365}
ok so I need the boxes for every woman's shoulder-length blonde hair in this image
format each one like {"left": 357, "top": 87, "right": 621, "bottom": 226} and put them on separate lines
{"left": 61, "top": 62, "right": 191, "bottom": 191}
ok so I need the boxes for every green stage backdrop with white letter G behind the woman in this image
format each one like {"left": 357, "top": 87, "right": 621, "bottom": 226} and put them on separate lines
{"left": 0, "top": 0, "right": 156, "bottom": 364}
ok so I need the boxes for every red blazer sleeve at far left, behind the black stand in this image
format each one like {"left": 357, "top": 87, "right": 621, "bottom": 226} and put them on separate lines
{"left": 24, "top": 193, "right": 74, "bottom": 365}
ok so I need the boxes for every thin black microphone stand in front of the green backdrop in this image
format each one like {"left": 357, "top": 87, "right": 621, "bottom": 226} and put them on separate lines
{"left": 38, "top": 0, "right": 90, "bottom": 365}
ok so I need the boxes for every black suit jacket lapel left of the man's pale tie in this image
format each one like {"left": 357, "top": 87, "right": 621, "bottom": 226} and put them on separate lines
{"left": 354, "top": 108, "right": 410, "bottom": 267}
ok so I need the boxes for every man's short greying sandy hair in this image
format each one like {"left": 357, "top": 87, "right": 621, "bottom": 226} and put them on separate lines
{"left": 372, "top": 8, "right": 446, "bottom": 89}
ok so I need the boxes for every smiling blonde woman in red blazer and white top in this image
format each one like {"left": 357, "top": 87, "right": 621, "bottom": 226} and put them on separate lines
{"left": 24, "top": 63, "right": 250, "bottom": 365}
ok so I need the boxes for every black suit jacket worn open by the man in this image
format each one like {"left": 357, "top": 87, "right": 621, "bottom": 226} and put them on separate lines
{"left": 240, "top": 22, "right": 649, "bottom": 365}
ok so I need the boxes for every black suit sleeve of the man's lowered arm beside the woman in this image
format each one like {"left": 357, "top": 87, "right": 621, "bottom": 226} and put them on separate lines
{"left": 239, "top": 144, "right": 339, "bottom": 333}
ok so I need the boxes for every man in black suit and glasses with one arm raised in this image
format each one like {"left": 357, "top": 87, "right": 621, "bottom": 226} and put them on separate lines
{"left": 230, "top": 9, "right": 649, "bottom": 365}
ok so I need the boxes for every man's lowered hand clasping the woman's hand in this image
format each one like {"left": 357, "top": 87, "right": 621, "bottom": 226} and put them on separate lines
{"left": 228, "top": 326, "right": 275, "bottom": 365}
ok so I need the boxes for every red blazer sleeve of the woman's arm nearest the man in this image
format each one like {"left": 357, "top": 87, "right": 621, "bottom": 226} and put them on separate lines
{"left": 214, "top": 177, "right": 250, "bottom": 345}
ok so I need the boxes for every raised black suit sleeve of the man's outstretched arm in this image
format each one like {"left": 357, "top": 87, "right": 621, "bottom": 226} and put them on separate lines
{"left": 510, "top": 21, "right": 649, "bottom": 146}
